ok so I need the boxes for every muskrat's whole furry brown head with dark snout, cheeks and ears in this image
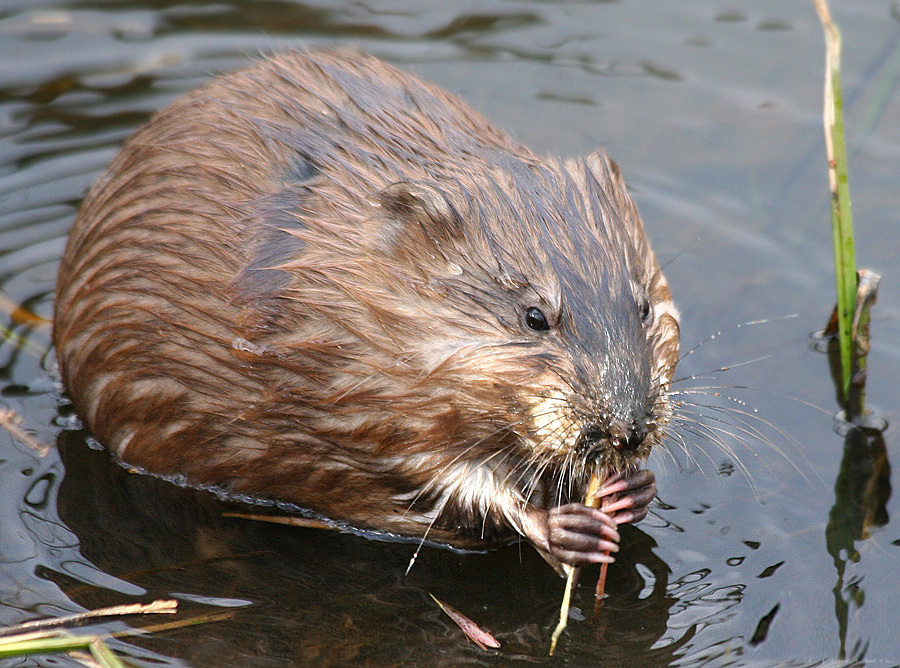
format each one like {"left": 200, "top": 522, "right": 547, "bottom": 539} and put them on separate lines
{"left": 243, "top": 153, "right": 679, "bottom": 500}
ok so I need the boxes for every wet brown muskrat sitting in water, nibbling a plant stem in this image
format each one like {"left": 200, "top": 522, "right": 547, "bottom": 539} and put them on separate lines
{"left": 53, "top": 52, "right": 679, "bottom": 564}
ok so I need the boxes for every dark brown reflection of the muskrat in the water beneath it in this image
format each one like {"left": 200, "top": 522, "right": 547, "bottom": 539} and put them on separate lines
{"left": 54, "top": 432, "right": 672, "bottom": 667}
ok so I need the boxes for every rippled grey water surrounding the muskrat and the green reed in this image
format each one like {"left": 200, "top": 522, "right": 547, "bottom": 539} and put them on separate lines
{"left": 0, "top": 0, "right": 900, "bottom": 667}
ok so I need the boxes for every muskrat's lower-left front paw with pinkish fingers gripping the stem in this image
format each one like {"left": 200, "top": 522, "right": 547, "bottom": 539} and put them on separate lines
{"left": 547, "top": 503, "right": 619, "bottom": 566}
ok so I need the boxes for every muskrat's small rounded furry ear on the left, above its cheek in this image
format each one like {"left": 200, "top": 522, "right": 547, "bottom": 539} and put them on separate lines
{"left": 378, "top": 181, "right": 465, "bottom": 250}
